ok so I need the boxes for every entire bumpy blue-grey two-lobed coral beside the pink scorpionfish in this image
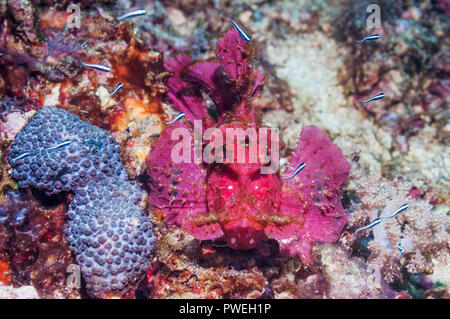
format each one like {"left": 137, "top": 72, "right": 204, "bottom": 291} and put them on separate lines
{"left": 9, "top": 107, "right": 154, "bottom": 297}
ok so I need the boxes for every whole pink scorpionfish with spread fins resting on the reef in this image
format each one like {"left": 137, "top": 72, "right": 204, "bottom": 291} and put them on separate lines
{"left": 147, "top": 29, "right": 350, "bottom": 265}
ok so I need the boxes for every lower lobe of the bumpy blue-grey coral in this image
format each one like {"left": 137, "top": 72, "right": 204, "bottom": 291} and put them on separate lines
{"left": 64, "top": 180, "right": 155, "bottom": 297}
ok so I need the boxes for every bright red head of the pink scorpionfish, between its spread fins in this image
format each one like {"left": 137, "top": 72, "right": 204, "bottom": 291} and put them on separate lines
{"left": 207, "top": 122, "right": 281, "bottom": 249}
